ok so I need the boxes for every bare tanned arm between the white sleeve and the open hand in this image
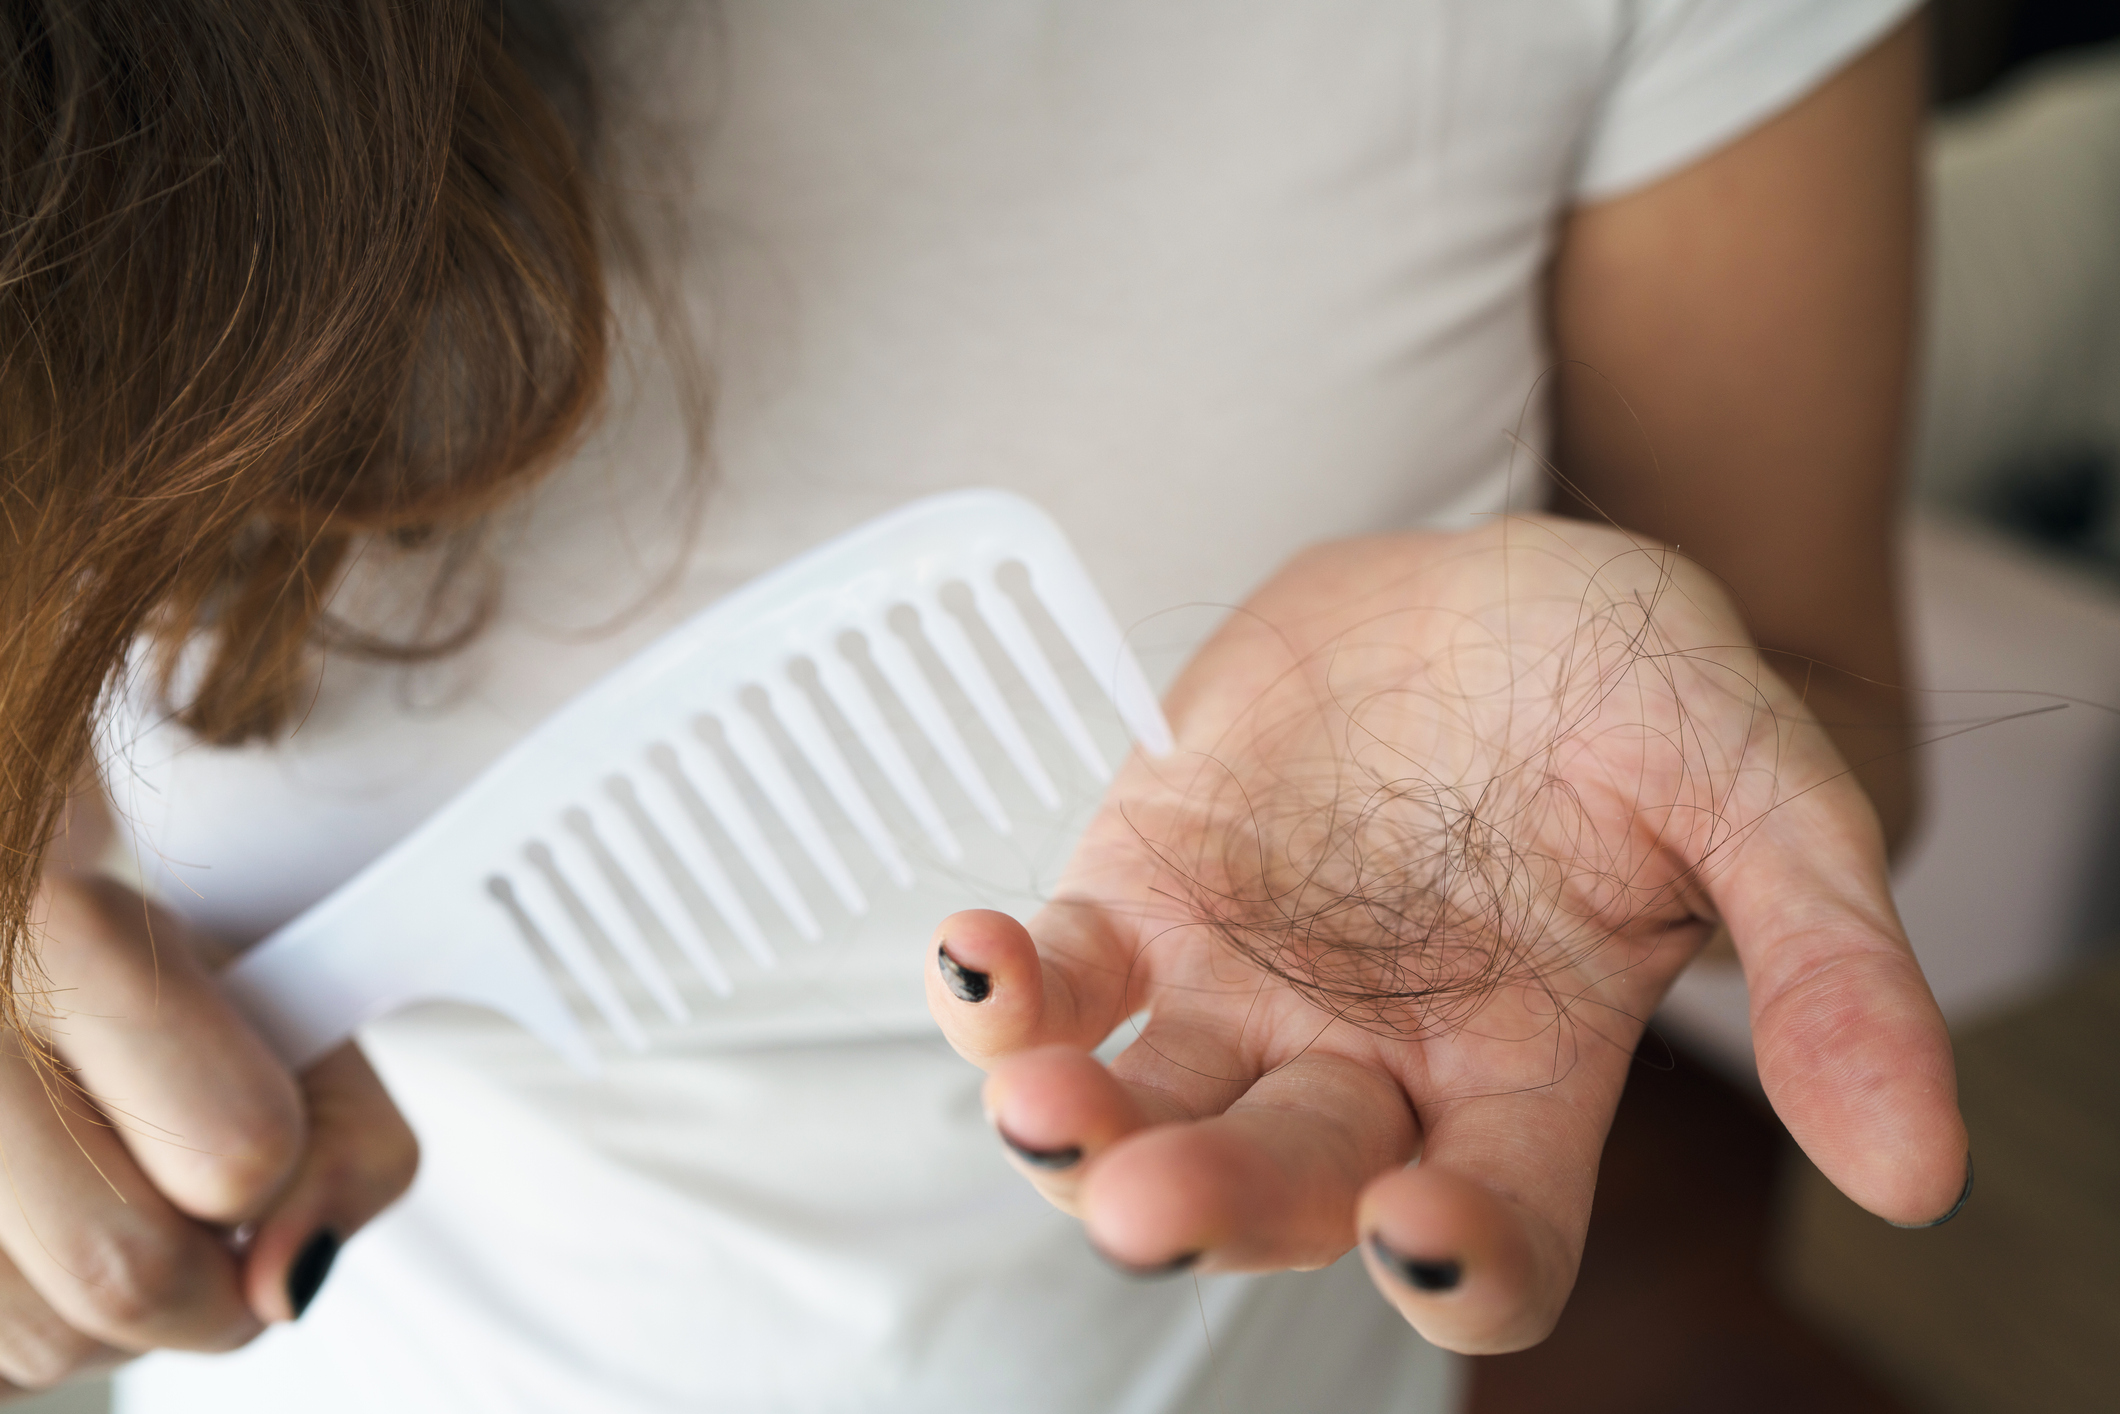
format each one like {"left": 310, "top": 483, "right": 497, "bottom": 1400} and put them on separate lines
{"left": 1552, "top": 13, "right": 1921, "bottom": 842}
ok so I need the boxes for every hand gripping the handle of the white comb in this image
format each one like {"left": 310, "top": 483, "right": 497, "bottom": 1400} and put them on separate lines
{"left": 0, "top": 793, "right": 420, "bottom": 1393}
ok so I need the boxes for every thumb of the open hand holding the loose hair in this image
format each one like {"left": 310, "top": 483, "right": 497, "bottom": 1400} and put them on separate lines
{"left": 1709, "top": 778, "right": 1969, "bottom": 1225}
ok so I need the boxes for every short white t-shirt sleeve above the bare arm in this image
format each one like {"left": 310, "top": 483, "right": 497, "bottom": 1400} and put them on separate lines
{"left": 1575, "top": 0, "right": 1919, "bottom": 201}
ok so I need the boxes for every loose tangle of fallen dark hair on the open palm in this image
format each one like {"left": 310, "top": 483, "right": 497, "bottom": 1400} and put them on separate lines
{"left": 1136, "top": 536, "right": 1780, "bottom": 1039}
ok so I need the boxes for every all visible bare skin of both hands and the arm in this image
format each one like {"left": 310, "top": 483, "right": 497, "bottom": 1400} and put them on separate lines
{"left": 0, "top": 13, "right": 1965, "bottom": 1389}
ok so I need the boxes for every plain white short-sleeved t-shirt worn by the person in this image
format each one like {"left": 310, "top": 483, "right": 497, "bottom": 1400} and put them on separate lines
{"left": 108, "top": 0, "right": 1910, "bottom": 1414}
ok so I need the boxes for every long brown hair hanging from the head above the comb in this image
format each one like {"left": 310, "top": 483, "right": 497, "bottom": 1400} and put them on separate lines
{"left": 0, "top": 0, "right": 608, "bottom": 1024}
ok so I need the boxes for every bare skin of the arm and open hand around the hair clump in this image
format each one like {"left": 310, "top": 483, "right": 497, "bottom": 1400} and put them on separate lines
{"left": 929, "top": 13, "right": 1969, "bottom": 1353}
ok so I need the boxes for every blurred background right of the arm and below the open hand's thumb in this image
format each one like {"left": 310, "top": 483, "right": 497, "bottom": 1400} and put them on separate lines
{"left": 11, "top": 0, "right": 2120, "bottom": 1414}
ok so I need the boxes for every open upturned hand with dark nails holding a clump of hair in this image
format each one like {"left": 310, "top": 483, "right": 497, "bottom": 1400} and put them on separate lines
{"left": 929, "top": 517, "right": 1969, "bottom": 1350}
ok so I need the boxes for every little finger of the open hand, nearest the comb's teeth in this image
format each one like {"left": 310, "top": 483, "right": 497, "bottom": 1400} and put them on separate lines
{"left": 926, "top": 901, "right": 1138, "bottom": 1068}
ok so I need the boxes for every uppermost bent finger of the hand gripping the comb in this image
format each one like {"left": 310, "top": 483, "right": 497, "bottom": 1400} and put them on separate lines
{"left": 40, "top": 880, "right": 303, "bottom": 1225}
